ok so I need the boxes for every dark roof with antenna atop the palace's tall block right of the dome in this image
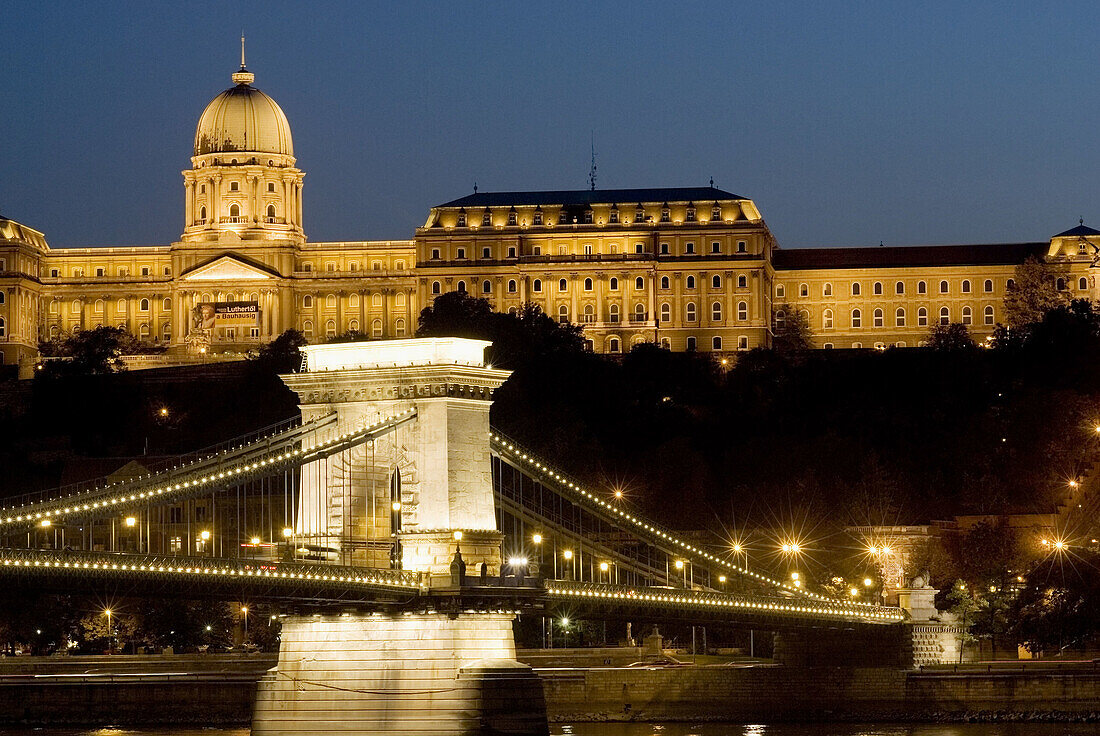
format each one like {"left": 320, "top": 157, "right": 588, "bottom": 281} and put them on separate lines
{"left": 437, "top": 187, "right": 747, "bottom": 208}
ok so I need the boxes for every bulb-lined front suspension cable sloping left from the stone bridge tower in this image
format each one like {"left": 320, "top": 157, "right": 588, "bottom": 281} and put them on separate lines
{"left": 0, "top": 408, "right": 416, "bottom": 527}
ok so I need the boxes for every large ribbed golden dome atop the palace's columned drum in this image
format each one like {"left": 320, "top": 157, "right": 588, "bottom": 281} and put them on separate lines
{"left": 195, "top": 67, "right": 294, "bottom": 156}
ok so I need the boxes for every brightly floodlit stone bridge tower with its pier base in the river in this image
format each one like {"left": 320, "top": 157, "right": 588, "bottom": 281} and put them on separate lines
{"left": 252, "top": 338, "right": 548, "bottom": 736}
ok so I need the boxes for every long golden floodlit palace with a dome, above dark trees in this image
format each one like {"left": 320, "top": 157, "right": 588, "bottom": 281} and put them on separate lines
{"left": 0, "top": 66, "right": 1100, "bottom": 375}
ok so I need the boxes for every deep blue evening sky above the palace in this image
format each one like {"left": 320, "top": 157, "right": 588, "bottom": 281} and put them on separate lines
{"left": 0, "top": 0, "right": 1100, "bottom": 246}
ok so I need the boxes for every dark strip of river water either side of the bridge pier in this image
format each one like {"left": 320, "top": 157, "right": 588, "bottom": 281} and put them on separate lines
{"left": 0, "top": 723, "right": 1100, "bottom": 736}
